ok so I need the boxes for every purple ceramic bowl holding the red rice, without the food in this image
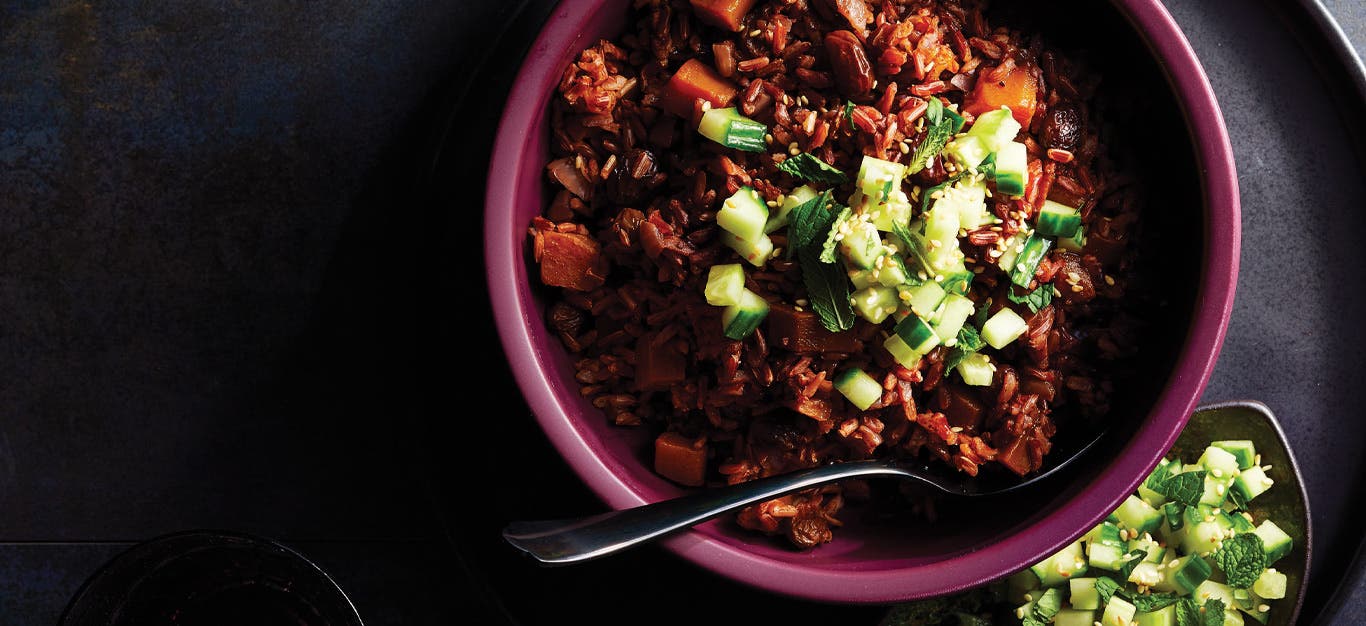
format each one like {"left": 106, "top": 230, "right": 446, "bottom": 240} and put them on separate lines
{"left": 485, "top": 0, "right": 1239, "bottom": 604}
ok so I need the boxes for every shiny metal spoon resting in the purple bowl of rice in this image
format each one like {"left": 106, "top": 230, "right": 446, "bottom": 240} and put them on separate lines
{"left": 503, "top": 431, "right": 1105, "bottom": 564}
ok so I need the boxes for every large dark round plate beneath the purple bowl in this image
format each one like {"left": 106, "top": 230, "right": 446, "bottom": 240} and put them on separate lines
{"left": 432, "top": 0, "right": 1366, "bottom": 625}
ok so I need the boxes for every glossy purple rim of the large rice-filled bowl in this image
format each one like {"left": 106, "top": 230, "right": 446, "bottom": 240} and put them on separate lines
{"left": 484, "top": 0, "right": 1242, "bottom": 604}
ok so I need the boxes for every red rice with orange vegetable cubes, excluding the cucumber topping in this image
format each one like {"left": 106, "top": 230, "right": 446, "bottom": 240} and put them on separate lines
{"left": 530, "top": 0, "right": 1138, "bottom": 548}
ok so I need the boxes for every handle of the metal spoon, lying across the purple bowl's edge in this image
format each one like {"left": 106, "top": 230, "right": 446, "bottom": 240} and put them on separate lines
{"left": 503, "top": 461, "right": 907, "bottom": 564}
